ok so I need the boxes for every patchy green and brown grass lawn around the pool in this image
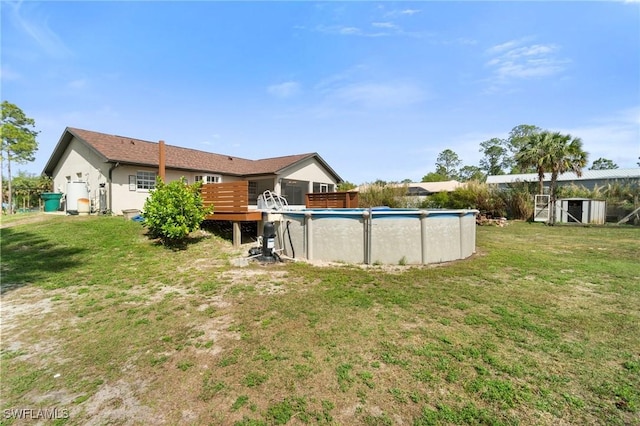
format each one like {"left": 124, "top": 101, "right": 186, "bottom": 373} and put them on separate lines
{"left": 0, "top": 216, "right": 640, "bottom": 425}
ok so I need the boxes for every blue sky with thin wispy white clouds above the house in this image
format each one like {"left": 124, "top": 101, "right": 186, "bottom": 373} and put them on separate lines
{"left": 1, "top": 1, "right": 640, "bottom": 183}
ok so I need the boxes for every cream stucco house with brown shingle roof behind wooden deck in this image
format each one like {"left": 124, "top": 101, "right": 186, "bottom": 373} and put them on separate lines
{"left": 43, "top": 127, "right": 342, "bottom": 214}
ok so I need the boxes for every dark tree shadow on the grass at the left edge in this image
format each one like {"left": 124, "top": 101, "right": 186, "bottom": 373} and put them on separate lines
{"left": 0, "top": 228, "right": 86, "bottom": 294}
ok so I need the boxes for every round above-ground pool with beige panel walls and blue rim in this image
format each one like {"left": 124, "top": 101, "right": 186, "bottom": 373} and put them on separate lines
{"left": 267, "top": 208, "right": 478, "bottom": 265}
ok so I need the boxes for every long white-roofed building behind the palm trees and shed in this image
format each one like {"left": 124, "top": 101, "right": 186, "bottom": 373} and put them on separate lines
{"left": 487, "top": 168, "right": 640, "bottom": 190}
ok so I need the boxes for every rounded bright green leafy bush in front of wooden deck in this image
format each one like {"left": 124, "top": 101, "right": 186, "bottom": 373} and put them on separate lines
{"left": 142, "top": 177, "right": 209, "bottom": 245}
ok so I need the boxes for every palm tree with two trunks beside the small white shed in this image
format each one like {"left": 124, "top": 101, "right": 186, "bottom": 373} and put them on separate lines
{"left": 515, "top": 131, "right": 588, "bottom": 222}
